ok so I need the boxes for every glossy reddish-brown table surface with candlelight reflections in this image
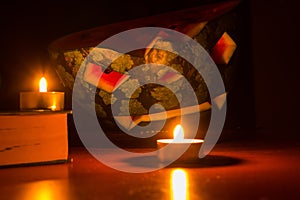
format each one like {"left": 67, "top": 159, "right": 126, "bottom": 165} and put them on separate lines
{"left": 0, "top": 135, "right": 300, "bottom": 200}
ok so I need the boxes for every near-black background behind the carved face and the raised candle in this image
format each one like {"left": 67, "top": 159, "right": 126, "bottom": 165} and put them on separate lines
{"left": 0, "top": 0, "right": 299, "bottom": 137}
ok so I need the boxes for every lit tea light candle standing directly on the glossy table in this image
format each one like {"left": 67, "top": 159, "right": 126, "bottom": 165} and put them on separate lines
{"left": 157, "top": 124, "right": 204, "bottom": 162}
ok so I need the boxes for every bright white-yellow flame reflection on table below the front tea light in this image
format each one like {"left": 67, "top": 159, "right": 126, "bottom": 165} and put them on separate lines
{"left": 170, "top": 169, "right": 189, "bottom": 200}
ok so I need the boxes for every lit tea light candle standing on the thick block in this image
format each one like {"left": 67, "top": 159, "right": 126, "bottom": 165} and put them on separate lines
{"left": 20, "top": 77, "right": 64, "bottom": 111}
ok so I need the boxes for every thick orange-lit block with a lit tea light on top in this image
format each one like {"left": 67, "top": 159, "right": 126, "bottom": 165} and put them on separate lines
{"left": 0, "top": 111, "right": 68, "bottom": 166}
